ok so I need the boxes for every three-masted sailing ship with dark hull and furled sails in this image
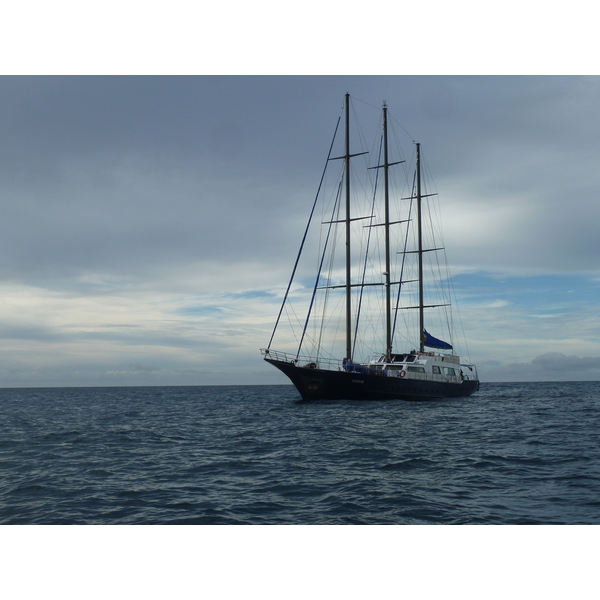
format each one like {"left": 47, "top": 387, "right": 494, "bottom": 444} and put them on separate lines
{"left": 261, "top": 94, "right": 479, "bottom": 400}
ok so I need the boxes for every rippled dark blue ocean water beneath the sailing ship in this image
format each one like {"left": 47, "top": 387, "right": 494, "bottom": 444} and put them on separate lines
{"left": 0, "top": 382, "right": 600, "bottom": 525}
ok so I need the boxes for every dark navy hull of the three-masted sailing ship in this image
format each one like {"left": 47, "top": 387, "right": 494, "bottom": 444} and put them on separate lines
{"left": 265, "top": 359, "right": 479, "bottom": 400}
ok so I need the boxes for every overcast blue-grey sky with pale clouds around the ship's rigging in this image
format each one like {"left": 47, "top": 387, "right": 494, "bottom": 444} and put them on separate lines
{"left": 0, "top": 76, "right": 600, "bottom": 387}
